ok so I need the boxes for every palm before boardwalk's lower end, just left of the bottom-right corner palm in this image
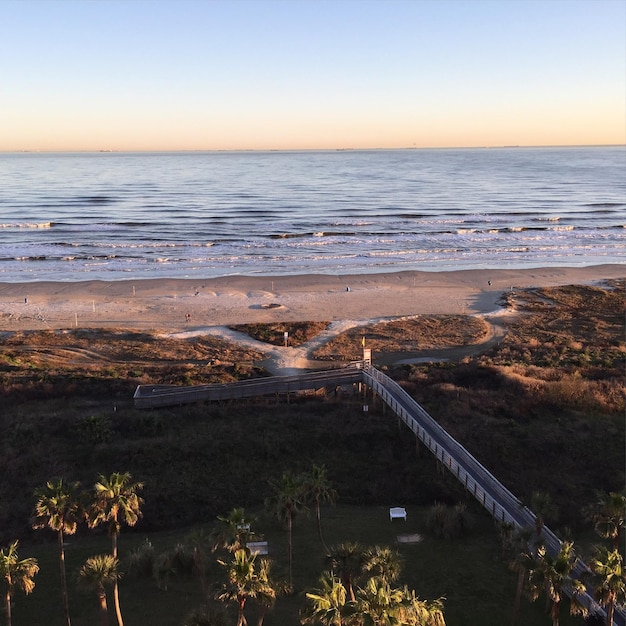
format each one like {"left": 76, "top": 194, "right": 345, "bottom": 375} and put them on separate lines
{"left": 528, "top": 541, "right": 586, "bottom": 626}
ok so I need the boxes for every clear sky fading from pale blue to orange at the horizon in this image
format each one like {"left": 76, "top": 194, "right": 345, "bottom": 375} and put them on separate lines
{"left": 0, "top": 0, "right": 626, "bottom": 151}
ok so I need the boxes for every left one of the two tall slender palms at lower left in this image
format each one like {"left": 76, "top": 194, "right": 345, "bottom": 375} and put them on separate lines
{"left": 33, "top": 478, "right": 81, "bottom": 626}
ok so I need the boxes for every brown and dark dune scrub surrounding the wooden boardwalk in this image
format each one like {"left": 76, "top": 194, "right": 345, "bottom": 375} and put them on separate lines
{"left": 0, "top": 281, "right": 626, "bottom": 624}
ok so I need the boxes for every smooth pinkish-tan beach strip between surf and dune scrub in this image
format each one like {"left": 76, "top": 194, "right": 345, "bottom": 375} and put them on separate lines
{"left": 0, "top": 265, "right": 626, "bottom": 332}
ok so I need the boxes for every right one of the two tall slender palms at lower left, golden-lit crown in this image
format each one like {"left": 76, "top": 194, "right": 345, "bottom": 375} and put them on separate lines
{"left": 89, "top": 472, "right": 143, "bottom": 626}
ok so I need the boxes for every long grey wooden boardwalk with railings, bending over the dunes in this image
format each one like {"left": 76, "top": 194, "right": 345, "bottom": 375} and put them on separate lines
{"left": 134, "top": 362, "right": 626, "bottom": 626}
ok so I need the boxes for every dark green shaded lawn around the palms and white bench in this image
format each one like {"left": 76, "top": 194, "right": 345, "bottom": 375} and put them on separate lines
{"left": 13, "top": 502, "right": 583, "bottom": 626}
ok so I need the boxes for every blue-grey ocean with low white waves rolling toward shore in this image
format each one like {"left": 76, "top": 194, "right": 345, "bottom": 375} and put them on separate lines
{"left": 0, "top": 146, "right": 626, "bottom": 282}
